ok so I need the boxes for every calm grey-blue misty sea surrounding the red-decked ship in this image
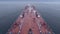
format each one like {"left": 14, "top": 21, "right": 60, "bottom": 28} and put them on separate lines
{"left": 0, "top": 2, "right": 60, "bottom": 34}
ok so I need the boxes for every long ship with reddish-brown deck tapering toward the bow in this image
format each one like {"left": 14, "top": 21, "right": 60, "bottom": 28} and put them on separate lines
{"left": 7, "top": 4, "right": 55, "bottom": 34}
